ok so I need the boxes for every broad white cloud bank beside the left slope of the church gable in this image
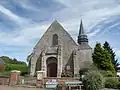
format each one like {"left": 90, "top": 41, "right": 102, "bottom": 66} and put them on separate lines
{"left": 0, "top": 22, "right": 48, "bottom": 46}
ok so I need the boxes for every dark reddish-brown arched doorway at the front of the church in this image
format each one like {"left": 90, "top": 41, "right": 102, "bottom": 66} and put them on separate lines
{"left": 47, "top": 57, "right": 57, "bottom": 77}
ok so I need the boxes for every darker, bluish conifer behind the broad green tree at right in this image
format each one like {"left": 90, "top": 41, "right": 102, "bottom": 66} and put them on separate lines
{"left": 103, "top": 41, "right": 119, "bottom": 71}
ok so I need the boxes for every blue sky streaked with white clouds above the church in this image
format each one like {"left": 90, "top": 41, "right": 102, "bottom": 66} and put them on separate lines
{"left": 0, "top": 0, "right": 120, "bottom": 62}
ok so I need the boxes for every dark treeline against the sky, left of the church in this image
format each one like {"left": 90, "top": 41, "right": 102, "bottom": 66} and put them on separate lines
{"left": 0, "top": 56, "right": 26, "bottom": 65}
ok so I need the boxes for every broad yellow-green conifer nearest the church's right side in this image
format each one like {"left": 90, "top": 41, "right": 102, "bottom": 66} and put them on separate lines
{"left": 92, "top": 43, "right": 115, "bottom": 73}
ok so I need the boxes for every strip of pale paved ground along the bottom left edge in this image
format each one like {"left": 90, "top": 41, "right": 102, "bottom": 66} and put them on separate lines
{"left": 0, "top": 86, "right": 45, "bottom": 90}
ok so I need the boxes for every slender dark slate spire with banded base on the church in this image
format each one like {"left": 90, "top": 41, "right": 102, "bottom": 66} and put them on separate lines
{"left": 78, "top": 20, "right": 88, "bottom": 44}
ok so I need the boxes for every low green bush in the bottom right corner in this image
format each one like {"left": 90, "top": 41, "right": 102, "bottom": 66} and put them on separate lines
{"left": 105, "top": 77, "right": 120, "bottom": 89}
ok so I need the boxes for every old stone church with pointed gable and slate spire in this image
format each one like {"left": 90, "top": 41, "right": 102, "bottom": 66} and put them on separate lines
{"left": 27, "top": 20, "right": 92, "bottom": 78}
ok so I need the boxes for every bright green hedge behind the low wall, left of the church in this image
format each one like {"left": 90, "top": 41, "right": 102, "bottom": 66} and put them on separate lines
{"left": 5, "top": 64, "right": 27, "bottom": 75}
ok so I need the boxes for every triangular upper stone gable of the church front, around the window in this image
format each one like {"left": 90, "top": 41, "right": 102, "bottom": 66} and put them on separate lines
{"left": 34, "top": 20, "right": 77, "bottom": 55}
